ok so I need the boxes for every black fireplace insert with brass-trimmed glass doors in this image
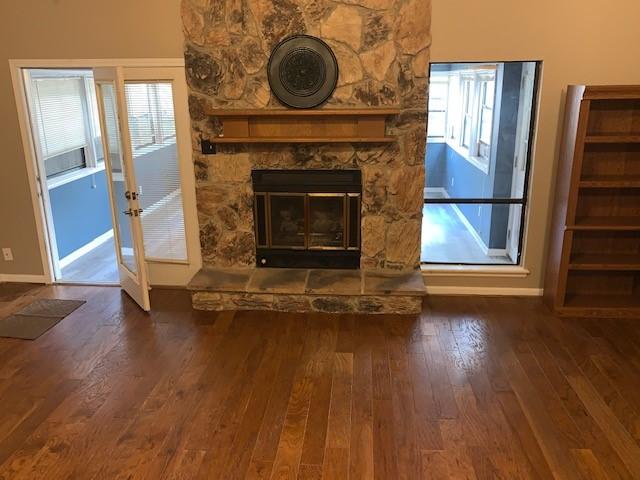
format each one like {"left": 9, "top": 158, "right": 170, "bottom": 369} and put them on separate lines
{"left": 252, "top": 170, "right": 362, "bottom": 269}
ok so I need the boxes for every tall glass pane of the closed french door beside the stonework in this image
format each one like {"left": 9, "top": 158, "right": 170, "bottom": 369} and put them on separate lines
{"left": 125, "top": 82, "right": 187, "bottom": 261}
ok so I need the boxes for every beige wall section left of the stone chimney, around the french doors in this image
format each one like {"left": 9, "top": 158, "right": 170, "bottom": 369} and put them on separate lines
{"left": 0, "top": 0, "right": 183, "bottom": 275}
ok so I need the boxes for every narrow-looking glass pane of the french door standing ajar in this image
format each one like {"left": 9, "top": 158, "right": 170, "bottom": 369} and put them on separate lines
{"left": 100, "top": 83, "right": 137, "bottom": 274}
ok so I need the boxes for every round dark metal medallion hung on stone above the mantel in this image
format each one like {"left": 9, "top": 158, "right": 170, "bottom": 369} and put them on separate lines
{"left": 268, "top": 35, "right": 338, "bottom": 108}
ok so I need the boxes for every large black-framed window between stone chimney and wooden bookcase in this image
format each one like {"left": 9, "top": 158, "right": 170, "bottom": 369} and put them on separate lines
{"left": 422, "top": 62, "right": 539, "bottom": 265}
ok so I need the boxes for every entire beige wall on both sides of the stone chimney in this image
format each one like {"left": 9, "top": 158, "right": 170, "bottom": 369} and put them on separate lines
{"left": 0, "top": 0, "right": 640, "bottom": 288}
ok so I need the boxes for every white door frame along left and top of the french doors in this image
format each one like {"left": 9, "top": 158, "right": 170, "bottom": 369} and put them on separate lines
{"left": 9, "top": 58, "right": 190, "bottom": 284}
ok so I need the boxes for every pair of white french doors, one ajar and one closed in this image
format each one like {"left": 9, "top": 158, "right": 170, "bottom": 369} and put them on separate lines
{"left": 94, "top": 67, "right": 201, "bottom": 309}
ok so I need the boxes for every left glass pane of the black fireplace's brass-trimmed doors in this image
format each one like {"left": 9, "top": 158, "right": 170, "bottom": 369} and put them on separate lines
{"left": 269, "top": 193, "right": 305, "bottom": 248}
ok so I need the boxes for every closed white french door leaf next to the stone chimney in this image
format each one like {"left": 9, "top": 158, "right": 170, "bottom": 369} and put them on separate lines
{"left": 121, "top": 67, "right": 202, "bottom": 286}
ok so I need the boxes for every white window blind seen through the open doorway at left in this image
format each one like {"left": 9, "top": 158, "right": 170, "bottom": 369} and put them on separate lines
{"left": 32, "top": 78, "right": 87, "bottom": 159}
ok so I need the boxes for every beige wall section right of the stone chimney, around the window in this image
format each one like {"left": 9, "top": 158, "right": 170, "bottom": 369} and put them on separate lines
{"left": 427, "top": 0, "right": 640, "bottom": 288}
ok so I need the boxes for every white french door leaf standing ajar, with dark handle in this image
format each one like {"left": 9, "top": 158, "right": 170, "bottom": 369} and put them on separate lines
{"left": 93, "top": 68, "right": 151, "bottom": 311}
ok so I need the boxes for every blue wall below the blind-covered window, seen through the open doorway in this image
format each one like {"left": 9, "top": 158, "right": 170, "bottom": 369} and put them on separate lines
{"left": 49, "top": 170, "right": 112, "bottom": 258}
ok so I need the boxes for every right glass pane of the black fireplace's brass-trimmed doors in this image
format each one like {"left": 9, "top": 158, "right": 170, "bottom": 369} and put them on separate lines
{"left": 309, "top": 194, "right": 345, "bottom": 248}
